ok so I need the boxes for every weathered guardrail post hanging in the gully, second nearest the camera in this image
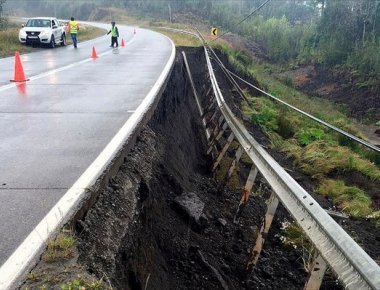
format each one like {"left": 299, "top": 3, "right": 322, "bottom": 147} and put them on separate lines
{"left": 247, "top": 193, "right": 279, "bottom": 273}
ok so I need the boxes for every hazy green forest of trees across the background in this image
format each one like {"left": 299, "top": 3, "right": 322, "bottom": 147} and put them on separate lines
{"left": 0, "top": 0, "right": 380, "bottom": 78}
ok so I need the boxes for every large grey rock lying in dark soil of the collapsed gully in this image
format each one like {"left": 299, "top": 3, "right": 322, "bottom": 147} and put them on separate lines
{"left": 174, "top": 192, "right": 207, "bottom": 226}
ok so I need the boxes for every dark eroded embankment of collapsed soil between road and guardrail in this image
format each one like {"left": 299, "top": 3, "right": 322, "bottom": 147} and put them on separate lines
{"left": 24, "top": 48, "right": 322, "bottom": 289}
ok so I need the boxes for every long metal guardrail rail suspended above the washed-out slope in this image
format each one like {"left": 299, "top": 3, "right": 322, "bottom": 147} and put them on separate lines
{"left": 160, "top": 27, "right": 380, "bottom": 290}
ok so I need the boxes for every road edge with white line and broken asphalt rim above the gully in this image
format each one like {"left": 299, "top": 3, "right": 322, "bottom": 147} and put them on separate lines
{"left": 0, "top": 31, "right": 176, "bottom": 290}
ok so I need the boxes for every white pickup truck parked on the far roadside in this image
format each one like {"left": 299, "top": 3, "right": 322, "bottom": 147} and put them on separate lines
{"left": 19, "top": 17, "right": 66, "bottom": 48}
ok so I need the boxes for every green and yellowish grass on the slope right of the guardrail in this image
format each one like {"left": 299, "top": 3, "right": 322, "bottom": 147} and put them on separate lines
{"left": 214, "top": 43, "right": 380, "bottom": 219}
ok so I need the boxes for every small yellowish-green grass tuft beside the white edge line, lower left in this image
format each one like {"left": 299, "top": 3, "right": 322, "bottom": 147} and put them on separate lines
{"left": 42, "top": 231, "right": 75, "bottom": 263}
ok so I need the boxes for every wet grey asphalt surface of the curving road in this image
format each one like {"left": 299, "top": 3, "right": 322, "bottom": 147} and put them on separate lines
{"left": 0, "top": 24, "right": 172, "bottom": 265}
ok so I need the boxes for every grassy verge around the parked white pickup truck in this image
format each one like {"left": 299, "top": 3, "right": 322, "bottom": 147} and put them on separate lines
{"left": 0, "top": 25, "right": 105, "bottom": 57}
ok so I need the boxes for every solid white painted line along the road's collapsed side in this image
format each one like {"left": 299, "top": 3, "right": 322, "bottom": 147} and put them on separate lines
{"left": 0, "top": 30, "right": 176, "bottom": 290}
